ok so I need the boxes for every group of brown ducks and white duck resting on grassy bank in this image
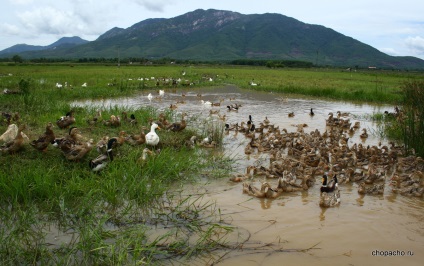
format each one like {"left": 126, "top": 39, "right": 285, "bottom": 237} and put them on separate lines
{"left": 0, "top": 102, "right": 190, "bottom": 172}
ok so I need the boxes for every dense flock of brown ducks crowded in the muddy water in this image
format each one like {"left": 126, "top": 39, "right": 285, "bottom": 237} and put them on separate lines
{"left": 226, "top": 109, "right": 424, "bottom": 207}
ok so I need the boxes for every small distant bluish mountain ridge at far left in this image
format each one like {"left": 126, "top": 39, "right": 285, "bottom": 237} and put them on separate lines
{"left": 0, "top": 36, "right": 88, "bottom": 56}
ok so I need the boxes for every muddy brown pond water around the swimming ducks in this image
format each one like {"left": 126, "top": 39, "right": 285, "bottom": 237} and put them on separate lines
{"left": 73, "top": 86, "right": 424, "bottom": 266}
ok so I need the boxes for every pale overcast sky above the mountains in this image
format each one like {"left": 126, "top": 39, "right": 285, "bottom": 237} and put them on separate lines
{"left": 0, "top": 0, "right": 424, "bottom": 59}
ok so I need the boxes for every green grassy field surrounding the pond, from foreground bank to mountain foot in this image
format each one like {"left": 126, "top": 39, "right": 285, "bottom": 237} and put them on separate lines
{"left": 0, "top": 64, "right": 423, "bottom": 265}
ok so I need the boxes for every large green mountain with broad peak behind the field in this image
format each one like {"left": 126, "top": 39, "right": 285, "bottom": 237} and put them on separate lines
{"left": 0, "top": 9, "right": 424, "bottom": 69}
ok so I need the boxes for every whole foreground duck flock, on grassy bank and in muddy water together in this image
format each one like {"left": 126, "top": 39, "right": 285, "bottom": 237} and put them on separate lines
{"left": 0, "top": 90, "right": 424, "bottom": 207}
